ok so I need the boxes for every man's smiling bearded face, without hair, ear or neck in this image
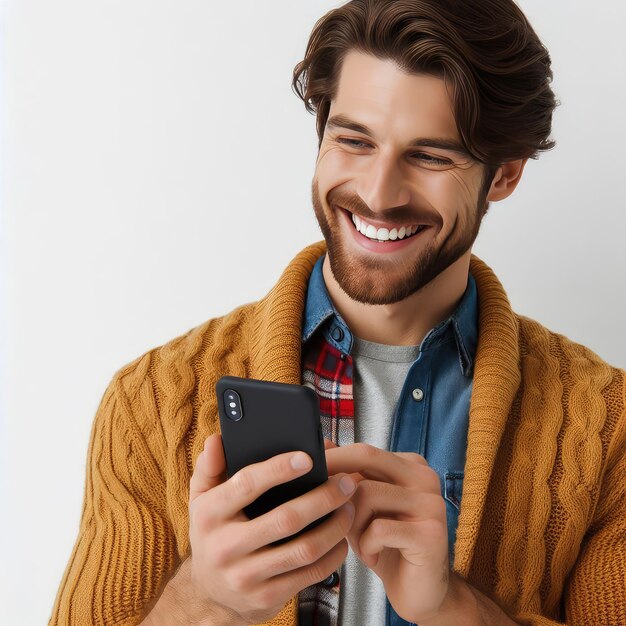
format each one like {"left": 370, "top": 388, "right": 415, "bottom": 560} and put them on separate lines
{"left": 312, "top": 51, "right": 488, "bottom": 304}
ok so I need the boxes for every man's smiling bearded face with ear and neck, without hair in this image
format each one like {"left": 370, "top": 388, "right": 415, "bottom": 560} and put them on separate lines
{"left": 313, "top": 50, "right": 526, "bottom": 345}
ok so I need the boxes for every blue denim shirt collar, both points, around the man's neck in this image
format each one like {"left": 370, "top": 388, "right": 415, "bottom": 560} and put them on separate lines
{"left": 302, "top": 254, "right": 478, "bottom": 376}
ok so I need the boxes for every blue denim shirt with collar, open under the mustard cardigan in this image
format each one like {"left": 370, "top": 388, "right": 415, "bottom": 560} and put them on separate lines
{"left": 302, "top": 255, "right": 478, "bottom": 626}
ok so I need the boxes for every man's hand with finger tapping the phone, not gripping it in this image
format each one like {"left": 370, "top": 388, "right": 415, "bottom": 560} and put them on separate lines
{"left": 324, "top": 440, "right": 450, "bottom": 623}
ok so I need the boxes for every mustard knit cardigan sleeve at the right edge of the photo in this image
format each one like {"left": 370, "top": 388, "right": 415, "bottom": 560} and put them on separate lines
{"left": 514, "top": 402, "right": 626, "bottom": 626}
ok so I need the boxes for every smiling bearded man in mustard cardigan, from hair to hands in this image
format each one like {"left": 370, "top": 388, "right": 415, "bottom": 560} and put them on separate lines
{"left": 51, "top": 0, "right": 626, "bottom": 626}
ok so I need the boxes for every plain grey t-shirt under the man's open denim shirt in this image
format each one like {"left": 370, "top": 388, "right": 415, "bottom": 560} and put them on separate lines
{"left": 338, "top": 336, "right": 419, "bottom": 626}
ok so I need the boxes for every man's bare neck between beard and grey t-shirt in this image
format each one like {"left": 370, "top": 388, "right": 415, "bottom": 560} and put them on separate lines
{"left": 322, "top": 250, "right": 471, "bottom": 346}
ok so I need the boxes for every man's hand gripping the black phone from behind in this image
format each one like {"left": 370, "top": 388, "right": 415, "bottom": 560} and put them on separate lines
{"left": 189, "top": 434, "right": 356, "bottom": 624}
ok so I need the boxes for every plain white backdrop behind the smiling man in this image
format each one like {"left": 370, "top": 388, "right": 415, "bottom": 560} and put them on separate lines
{"left": 0, "top": 0, "right": 626, "bottom": 626}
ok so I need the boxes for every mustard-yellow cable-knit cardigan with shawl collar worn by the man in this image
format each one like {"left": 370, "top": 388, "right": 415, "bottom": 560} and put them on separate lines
{"left": 49, "top": 241, "right": 626, "bottom": 626}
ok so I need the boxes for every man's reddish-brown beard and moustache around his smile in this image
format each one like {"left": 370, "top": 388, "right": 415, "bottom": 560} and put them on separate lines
{"left": 312, "top": 178, "right": 490, "bottom": 304}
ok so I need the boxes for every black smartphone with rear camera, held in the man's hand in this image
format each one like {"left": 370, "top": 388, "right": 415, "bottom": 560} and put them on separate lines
{"left": 215, "top": 376, "right": 331, "bottom": 545}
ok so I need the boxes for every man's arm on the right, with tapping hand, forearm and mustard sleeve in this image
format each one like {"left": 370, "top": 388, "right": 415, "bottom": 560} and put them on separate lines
{"left": 327, "top": 426, "right": 626, "bottom": 626}
